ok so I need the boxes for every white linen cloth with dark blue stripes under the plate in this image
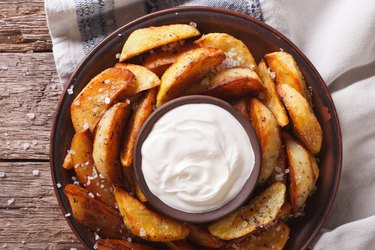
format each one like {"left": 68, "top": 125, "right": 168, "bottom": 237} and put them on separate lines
{"left": 45, "top": 0, "right": 375, "bottom": 247}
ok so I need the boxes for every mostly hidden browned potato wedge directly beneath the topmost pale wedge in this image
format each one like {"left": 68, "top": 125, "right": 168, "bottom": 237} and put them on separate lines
{"left": 143, "top": 44, "right": 198, "bottom": 77}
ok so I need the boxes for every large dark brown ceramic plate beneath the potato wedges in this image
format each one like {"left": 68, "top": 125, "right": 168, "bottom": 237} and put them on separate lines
{"left": 50, "top": 7, "right": 342, "bottom": 249}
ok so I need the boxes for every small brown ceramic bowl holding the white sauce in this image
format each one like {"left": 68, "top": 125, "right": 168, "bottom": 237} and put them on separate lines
{"left": 133, "top": 95, "right": 261, "bottom": 223}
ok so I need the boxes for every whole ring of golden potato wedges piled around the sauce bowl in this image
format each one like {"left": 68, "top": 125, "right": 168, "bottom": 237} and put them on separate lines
{"left": 62, "top": 24, "right": 323, "bottom": 249}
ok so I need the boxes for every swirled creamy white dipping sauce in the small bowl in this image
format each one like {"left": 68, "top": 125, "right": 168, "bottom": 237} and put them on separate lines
{"left": 141, "top": 104, "right": 255, "bottom": 213}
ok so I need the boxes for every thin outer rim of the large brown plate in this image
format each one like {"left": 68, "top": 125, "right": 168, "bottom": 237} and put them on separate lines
{"left": 49, "top": 6, "right": 343, "bottom": 249}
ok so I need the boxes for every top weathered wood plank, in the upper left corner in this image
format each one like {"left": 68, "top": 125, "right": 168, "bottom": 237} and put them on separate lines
{"left": 0, "top": 0, "right": 52, "bottom": 52}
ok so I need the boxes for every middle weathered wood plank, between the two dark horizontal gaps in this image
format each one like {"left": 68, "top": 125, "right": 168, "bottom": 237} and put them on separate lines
{"left": 0, "top": 53, "right": 61, "bottom": 160}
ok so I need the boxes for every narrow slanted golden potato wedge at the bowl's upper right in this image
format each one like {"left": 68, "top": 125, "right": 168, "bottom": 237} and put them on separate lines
{"left": 258, "top": 60, "right": 289, "bottom": 127}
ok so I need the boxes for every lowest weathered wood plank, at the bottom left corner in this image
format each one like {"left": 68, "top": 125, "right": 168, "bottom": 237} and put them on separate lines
{"left": 0, "top": 162, "right": 82, "bottom": 249}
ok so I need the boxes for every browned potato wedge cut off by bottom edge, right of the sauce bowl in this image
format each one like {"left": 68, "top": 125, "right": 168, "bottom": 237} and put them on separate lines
{"left": 229, "top": 221, "right": 290, "bottom": 250}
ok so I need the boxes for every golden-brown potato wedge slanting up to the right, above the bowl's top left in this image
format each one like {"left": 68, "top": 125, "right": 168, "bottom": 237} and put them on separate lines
{"left": 156, "top": 48, "right": 225, "bottom": 107}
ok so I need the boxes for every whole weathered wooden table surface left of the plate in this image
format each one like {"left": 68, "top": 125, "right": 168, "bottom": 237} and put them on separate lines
{"left": 0, "top": 0, "right": 82, "bottom": 249}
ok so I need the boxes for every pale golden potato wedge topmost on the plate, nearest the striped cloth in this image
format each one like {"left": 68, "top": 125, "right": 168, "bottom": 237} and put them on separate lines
{"left": 120, "top": 24, "right": 200, "bottom": 62}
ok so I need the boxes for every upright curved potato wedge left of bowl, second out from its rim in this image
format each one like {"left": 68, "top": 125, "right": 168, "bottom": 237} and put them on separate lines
{"left": 93, "top": 102, "right": 130, "bottom": 185}
